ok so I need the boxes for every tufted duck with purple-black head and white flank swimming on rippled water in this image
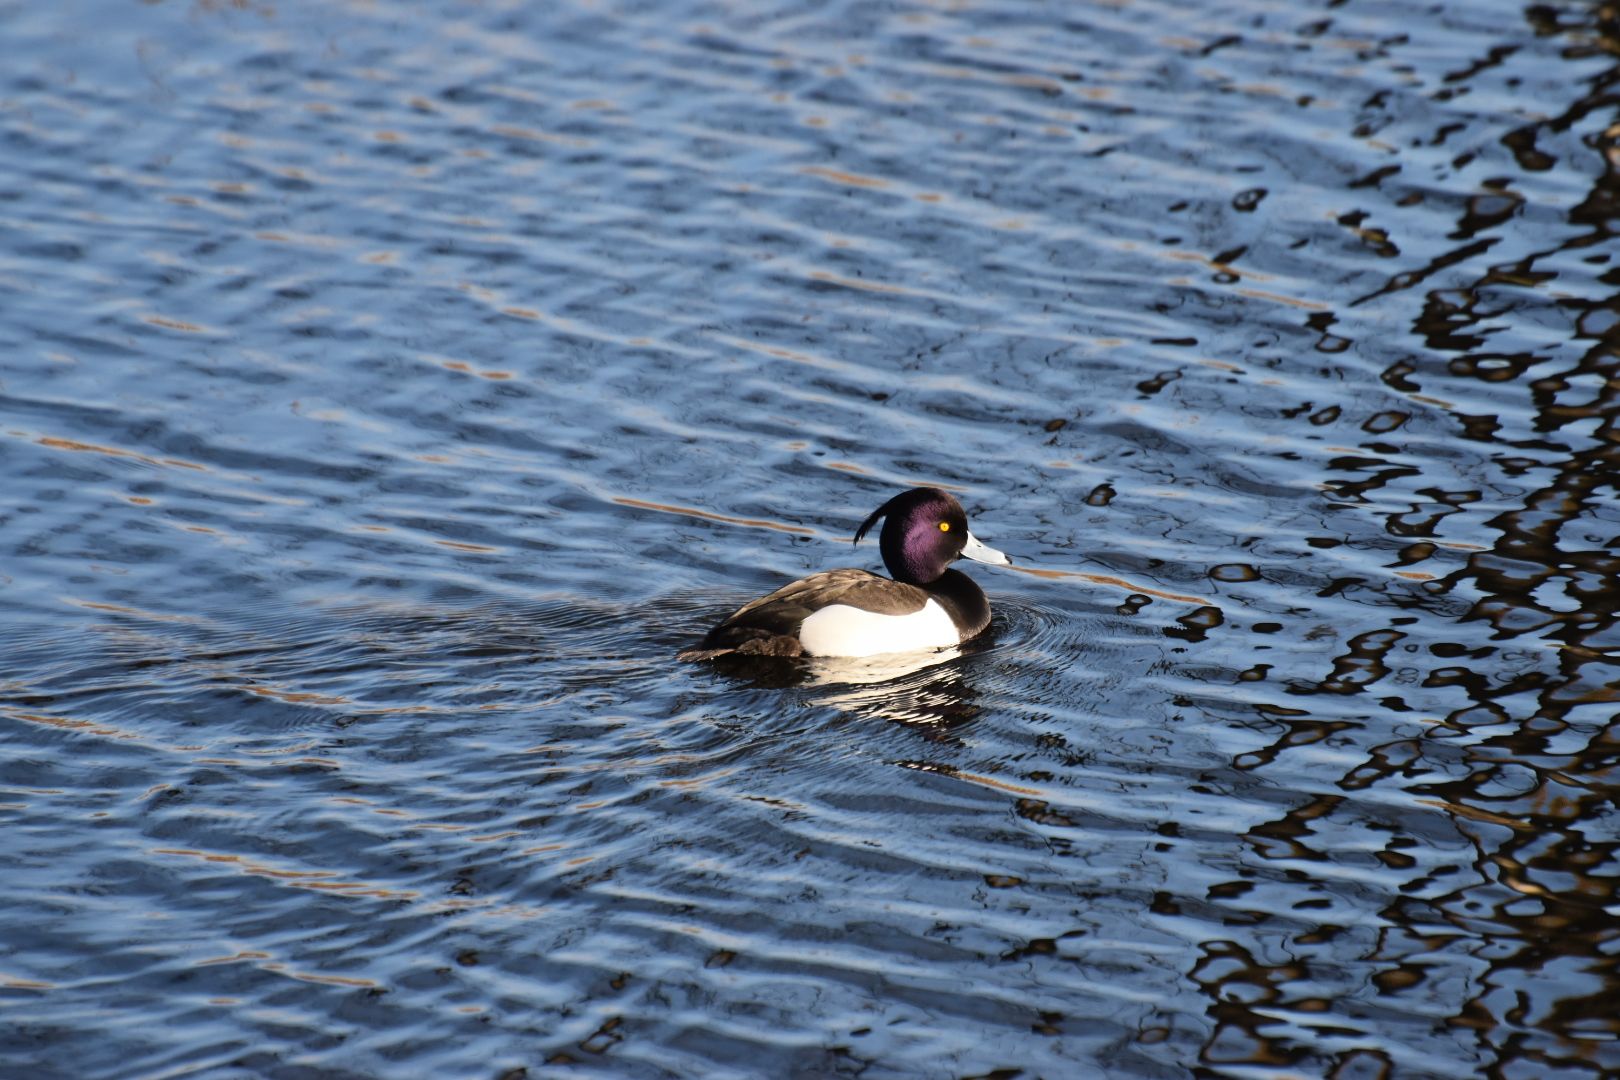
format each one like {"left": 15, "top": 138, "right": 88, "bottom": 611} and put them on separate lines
{"left": 679, "top": 487, "right": 1013, "bottom": 661}
